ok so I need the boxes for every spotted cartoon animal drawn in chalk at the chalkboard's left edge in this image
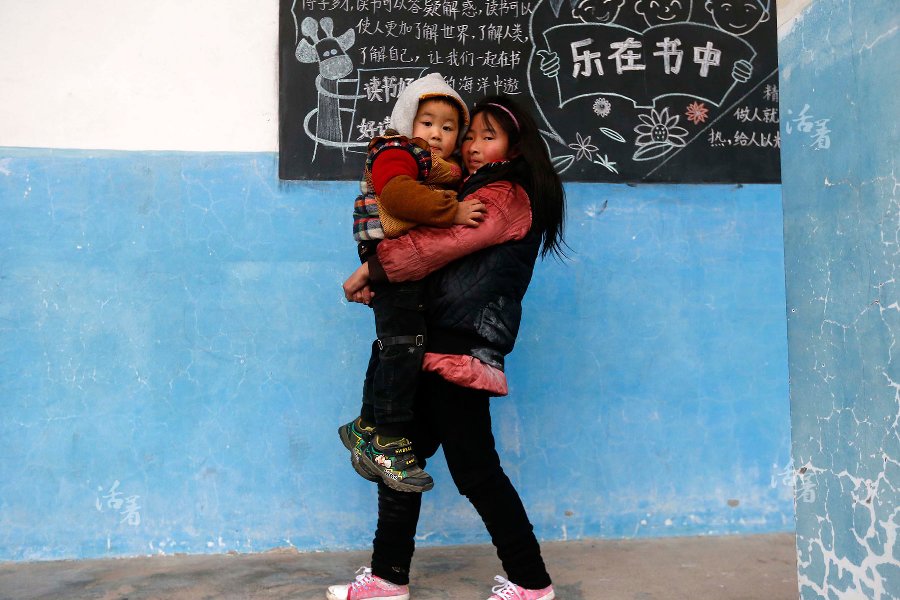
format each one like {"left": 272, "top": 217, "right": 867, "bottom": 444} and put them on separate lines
{"left": 291, "top": 11, "right": 366, "bottom": 162}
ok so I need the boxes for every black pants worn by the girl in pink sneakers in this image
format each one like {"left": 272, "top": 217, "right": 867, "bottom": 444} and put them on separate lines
{"left": 364, "top": 373, "right": 550, "bottom": 589}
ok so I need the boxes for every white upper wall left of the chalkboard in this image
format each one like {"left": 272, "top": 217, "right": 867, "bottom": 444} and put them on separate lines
{"left": 0, "top": 0, "right": 278, "bottom": 151}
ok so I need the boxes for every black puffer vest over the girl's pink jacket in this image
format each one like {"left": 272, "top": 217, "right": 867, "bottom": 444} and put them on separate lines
{"left": 425, "top": 159, "right": 541, "bottom": 370}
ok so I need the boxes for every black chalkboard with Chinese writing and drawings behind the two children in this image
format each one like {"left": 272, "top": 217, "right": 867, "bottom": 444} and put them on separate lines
{"left": 279, "top": 0, "right": 781, "bottom": 183}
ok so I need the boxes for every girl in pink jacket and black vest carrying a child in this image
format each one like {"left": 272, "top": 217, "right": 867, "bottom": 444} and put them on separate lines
{"left": 327, "top": 96, "right": 565, "bottom": 600}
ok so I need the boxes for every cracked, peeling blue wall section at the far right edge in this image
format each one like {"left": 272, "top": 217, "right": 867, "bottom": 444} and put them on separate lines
{"left": 780, "top": 0, "right": 900, "bottom": 599}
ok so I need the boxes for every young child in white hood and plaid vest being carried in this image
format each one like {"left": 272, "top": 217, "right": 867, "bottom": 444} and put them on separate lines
{"left": 338, "top": 73, "right": 484, "bottom": 492}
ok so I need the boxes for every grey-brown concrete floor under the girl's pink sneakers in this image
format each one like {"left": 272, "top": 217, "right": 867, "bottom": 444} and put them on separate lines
{"left": 0, "top": 534, "right": 798, "bottom": 600}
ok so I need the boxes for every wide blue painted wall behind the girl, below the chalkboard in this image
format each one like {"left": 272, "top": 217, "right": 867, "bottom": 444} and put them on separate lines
{"left": 0, "top": 149, "right": 793, "bottom": 560}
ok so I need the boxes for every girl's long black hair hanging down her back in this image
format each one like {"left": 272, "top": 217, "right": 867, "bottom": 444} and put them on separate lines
{"left": 469, "top": 95, "right": 566, "bottom": 258}
